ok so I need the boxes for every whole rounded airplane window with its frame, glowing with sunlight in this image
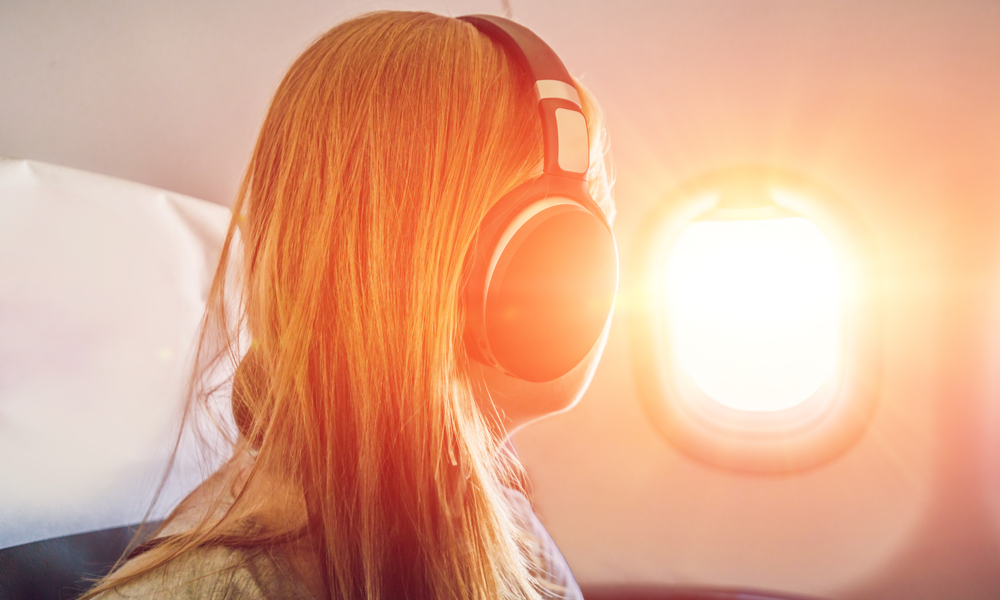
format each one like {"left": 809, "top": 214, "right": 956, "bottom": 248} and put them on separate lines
{"left": 625, "top": 167, "right": 882, "bottom": 472}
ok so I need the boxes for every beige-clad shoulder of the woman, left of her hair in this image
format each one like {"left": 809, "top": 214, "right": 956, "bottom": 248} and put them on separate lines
{"left": 96, "top": 546, "right": 312, "bottom": 600}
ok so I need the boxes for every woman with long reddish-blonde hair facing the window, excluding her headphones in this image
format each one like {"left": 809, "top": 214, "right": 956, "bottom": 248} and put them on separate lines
{"left": 88, "top": 12, "right": 611, "bottom": 600}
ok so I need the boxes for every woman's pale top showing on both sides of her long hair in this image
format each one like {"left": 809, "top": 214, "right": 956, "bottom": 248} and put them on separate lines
{"left": 97, "top": 490, "right": 583, "bottom": 600}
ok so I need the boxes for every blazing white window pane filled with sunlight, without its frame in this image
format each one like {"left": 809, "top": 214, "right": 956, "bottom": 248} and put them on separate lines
{"left": 664, "top": 217, "right": 843, "bottom": 412}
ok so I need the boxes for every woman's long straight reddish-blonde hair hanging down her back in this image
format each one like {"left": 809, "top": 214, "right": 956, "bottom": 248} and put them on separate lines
{"left": 237, "top": 13, "right": 541, "bottom": 597}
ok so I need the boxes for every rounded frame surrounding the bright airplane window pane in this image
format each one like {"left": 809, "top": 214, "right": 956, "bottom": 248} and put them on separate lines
{"left": 628, "top": 166, "right": 884, "bottom": 473}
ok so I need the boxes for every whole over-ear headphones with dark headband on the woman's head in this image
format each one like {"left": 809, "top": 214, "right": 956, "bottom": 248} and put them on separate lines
{"left": 459, "top": 15, "right": 618, "bottom": 382}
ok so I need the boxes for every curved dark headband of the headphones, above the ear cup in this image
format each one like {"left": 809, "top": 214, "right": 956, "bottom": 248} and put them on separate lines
{"left": 459, "top": 15, "right": 590, "bottom": 181}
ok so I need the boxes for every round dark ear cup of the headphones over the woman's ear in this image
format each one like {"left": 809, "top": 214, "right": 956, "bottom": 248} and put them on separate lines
{"left": 485, "top": 204, "right": 618, "bottom": 382}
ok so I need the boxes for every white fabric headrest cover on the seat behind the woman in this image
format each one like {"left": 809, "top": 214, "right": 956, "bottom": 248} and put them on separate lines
{"left": 0, "top": 159, "right": 230, "bottom": 548}
